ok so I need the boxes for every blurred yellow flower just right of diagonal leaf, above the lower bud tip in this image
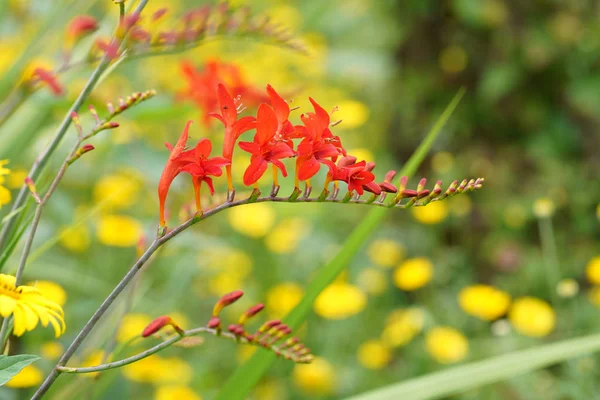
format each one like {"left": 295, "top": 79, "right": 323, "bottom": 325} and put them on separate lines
{"left": 314, "top": 282, "right": 367, "bottom": 319}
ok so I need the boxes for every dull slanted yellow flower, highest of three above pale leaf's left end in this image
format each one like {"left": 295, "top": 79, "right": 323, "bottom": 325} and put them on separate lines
{"left": 381, "top": 308, "right": 425, "bottom": 347}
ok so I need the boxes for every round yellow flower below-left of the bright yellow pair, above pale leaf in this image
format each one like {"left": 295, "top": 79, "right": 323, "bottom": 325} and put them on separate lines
{"left": 425, "top": 326, "right": 469, "bottom": 364}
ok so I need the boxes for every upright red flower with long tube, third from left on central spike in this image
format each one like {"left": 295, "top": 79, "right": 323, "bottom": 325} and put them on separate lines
{"left": 210, "top": 84, "right": 255, "bottom": 190}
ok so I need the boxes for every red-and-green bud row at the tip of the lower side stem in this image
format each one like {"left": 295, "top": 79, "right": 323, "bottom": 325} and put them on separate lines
{"left": 207, "top": 290, "right": 313, "bottom": 364}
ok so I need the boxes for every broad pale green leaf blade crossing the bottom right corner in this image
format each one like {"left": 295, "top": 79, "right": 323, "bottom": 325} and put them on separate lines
{"left": 347, "top": 334, "right": 600, "bottom": 400}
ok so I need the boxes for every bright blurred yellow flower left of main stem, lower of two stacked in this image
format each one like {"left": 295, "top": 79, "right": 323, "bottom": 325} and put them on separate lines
{"left": 96, "top": 215, "right": 143, "bottom": 247}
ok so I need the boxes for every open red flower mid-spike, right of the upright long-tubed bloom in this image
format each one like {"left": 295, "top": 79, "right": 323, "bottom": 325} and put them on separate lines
{"left": 239, "top": 103, "right": 294, "bottom": 186}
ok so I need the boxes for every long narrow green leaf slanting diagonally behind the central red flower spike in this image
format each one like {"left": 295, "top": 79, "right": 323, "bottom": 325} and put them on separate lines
{"left": 217, "top": 89, "right": 465, "bottom": 400}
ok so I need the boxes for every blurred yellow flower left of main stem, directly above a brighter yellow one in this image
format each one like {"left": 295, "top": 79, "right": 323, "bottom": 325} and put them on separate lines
{"left": 94, "top": 171, "right": 141, "bottom": 209}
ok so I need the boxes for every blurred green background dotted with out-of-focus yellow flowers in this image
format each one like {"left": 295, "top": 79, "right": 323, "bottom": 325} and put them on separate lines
{"left": 0, "top": 0, "right": 600, "bottom": 400}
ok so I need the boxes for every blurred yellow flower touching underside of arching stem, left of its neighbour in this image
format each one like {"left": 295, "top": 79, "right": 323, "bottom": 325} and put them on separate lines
{"left": 228, "top": 203, "right": 275, "bottom": 238}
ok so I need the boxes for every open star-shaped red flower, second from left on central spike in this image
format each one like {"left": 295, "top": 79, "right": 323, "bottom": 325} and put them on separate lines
{"left": 175, "top": 139, "right": 231, "bottom": 211}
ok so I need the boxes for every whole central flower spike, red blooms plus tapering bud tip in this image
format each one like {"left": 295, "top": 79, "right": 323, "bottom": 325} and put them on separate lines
{"left": 158, "top": 78, "right": 483, "bottom": 227}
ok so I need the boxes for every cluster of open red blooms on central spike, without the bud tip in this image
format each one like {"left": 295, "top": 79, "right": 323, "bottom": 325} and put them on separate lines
{"left": 158, "top": 83, "right": 397, "bottom": 226}
